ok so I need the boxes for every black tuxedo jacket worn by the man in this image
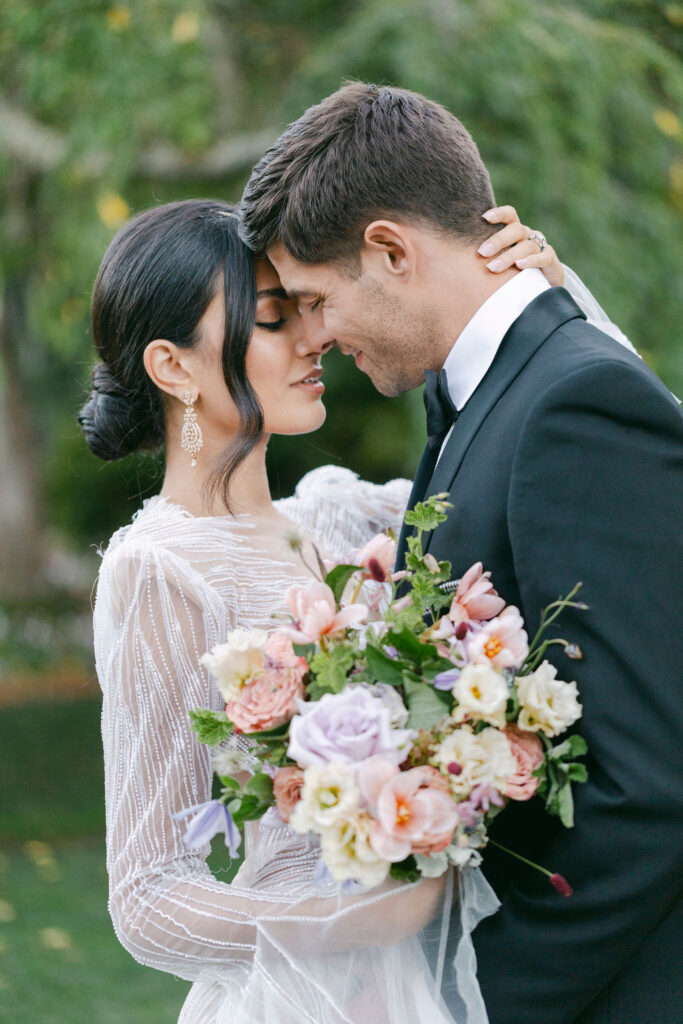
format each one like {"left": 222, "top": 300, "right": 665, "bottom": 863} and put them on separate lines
{"left": 399, "top": 288, "right": 683, "bottom": 1024}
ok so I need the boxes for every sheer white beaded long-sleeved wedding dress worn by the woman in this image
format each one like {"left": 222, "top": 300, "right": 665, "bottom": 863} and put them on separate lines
{"left": 94, "top": 272, "right": 634, "bottom": 1024}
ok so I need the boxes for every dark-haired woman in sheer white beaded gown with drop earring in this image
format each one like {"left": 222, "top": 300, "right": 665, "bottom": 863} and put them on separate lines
{"left": 80, "top": 200, "right": 634, "bottom": 1024}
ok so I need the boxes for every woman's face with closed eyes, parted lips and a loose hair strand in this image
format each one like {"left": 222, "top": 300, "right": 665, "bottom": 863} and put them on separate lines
{"left": 196, "top": 259, "right": 329, "bottom": 434}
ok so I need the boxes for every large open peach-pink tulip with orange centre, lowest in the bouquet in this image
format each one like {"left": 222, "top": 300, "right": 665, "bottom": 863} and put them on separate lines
{"left": 358, "top": 757, "right": 459, "bottom": 862}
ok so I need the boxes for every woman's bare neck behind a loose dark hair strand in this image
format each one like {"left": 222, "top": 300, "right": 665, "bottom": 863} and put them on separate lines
{"left": 161, "top": 437, "right": 272, "bottom": 516}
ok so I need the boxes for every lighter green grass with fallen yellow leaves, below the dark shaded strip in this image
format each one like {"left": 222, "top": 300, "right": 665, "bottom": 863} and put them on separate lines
{"left": 0, "top": 840, "right": 188, "bottom": 1024}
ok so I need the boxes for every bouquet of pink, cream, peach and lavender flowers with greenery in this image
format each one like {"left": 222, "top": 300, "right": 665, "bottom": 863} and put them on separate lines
{"left": 182, "top": 495, "right": 586, "bottom": 895}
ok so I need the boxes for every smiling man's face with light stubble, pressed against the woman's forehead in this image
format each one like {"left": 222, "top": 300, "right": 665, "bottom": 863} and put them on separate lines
{"left": 268, "top": 243, "right": 429, "bottom": 395}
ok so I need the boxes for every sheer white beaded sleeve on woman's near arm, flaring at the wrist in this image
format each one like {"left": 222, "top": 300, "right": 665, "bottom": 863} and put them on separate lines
{"left": 94, "top": 524, "right": 471, "bottom": 1024}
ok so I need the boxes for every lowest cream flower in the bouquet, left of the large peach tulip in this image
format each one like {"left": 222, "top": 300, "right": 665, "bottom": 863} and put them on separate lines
{"left": 319, "top": 806, "right": 391, "bottom": 887}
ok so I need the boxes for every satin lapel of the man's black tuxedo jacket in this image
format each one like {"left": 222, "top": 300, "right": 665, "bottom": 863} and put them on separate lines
{"left": 423, "top": 288, "right": 586, "bottom": 551}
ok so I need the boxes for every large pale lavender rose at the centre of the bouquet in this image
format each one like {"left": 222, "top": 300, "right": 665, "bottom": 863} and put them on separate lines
{"left": 288, "top": 686, "right": 416, "bottom": 768}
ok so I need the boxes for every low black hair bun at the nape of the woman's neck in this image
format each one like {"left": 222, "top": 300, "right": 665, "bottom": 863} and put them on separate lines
{"left": 78, "top": 362, "right": 164, "bottom": 462}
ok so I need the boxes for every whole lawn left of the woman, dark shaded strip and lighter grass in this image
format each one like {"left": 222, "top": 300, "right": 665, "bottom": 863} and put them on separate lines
{"left": 0, "top": 700, "right": 242, "bottom": 1024}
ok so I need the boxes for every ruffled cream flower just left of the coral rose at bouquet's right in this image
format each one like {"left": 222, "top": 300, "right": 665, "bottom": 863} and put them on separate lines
{"left": 436, "top": 726, "right": 517, "bottom": 796}
